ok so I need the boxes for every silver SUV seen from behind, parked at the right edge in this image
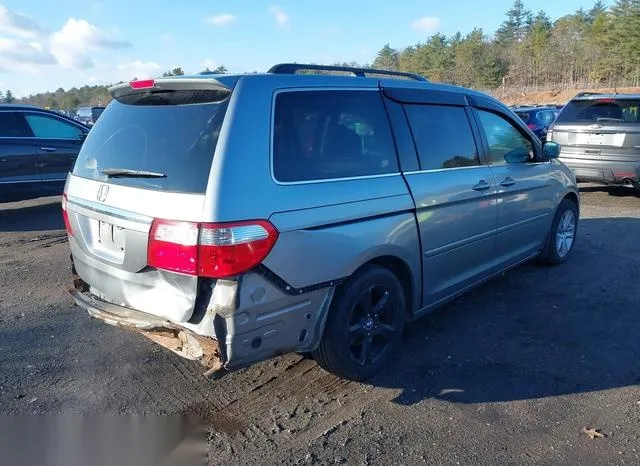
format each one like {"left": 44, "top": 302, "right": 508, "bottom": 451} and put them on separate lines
{"left": 547, "top": 93, "right": 640, "bottom": 188}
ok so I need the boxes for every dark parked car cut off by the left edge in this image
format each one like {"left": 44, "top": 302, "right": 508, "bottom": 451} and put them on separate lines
{"left": 0, "top": 105, "right": 89, "bottom": 201}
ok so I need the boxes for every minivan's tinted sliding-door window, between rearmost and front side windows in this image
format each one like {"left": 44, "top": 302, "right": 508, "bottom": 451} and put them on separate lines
{"left": 405, "top": 105, "right": 480, "bottom": 170}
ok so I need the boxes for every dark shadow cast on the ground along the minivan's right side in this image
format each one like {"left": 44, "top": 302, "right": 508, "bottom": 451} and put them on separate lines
{"left": 370, "top": 218, "right": 640, "bottom": 404}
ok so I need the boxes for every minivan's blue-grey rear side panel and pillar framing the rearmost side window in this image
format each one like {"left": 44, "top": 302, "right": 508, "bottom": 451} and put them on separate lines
{"left": 204, "top": 75, "right": 421, "bottom": 314}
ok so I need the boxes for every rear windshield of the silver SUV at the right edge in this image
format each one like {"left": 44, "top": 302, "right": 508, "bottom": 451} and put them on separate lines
{"left": 556, "top": 99, "right": 640, "bottom": 124}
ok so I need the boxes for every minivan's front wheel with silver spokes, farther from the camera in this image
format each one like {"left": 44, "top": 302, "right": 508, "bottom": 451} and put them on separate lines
{"left": 540, "top": 199, "right": 579, "bottom": 265}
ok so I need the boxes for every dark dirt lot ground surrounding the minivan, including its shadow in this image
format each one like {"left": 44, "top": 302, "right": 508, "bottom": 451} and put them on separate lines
{"left": 0, "top": 189, "right": 640, "bottom": 465}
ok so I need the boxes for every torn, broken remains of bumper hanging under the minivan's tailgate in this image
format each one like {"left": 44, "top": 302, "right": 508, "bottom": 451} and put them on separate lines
{"left": 69, "top": 289, "right": 225, "bottom": 378}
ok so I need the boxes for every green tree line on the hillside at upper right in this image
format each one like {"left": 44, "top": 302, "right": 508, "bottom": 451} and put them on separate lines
{"left": 373, "top": 0, "right": 640, "bottom": 90}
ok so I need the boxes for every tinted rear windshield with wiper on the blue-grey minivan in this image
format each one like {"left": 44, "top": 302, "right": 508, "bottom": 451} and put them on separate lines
{"left": 73, "top": 91, "right": 229, "bottom": 193}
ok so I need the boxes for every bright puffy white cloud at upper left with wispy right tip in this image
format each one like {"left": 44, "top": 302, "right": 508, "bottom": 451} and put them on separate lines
{"left": 50, "top": 18, "right": 131, "bottom": 69}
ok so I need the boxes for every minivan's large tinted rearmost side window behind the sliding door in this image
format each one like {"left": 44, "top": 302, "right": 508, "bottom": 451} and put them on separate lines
{"left": 273, "top": 91, "right": 398, "bottom": 182}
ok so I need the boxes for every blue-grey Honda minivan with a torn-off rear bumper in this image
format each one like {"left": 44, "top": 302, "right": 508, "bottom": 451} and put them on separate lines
{"left": 63, "top": 64, "right": 578, "bottom": 379}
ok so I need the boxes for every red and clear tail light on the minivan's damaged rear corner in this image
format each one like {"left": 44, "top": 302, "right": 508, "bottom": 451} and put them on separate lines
{"left": 147, "top": 219, "right": 278, "bottom": 278}
